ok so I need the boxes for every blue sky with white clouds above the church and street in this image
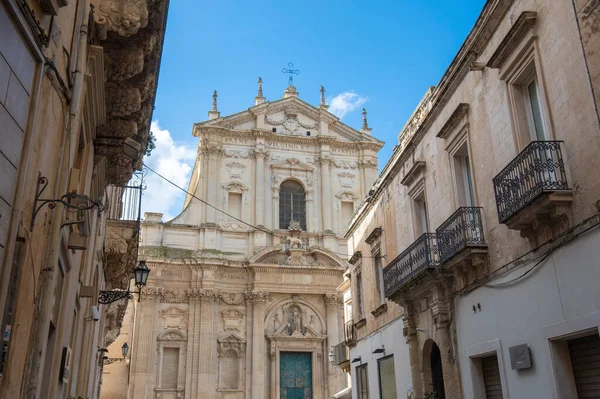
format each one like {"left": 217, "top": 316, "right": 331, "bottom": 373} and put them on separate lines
{"left": 144, "top": 0, "right": 485, "bottom": 220}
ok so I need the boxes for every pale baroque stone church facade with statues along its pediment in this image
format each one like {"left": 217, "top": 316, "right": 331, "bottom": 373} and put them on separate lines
{"left": 129, "top": 79, "right": 383, "bottom": 399}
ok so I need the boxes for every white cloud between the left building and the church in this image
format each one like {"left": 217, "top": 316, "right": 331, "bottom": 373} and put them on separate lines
{"left": 142, "top": 120, "right": 196, "bottom": 221}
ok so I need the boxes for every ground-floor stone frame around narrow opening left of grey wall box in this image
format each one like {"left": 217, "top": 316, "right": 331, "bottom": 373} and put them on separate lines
{"left": 466, "top": 339, "right": 508, "bottom": 398}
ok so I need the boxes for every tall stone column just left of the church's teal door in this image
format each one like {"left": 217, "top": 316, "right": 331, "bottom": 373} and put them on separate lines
{"left": 247, "top": 292, "right": 268, "bottom": 399}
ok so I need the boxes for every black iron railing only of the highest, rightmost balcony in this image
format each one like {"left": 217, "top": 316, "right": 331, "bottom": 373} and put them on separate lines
{"left": 493, "top": 141, "right": 569, "bottom": 223}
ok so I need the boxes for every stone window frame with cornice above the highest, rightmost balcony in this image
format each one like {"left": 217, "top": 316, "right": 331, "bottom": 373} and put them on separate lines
{"left": 487, "top": 11, "right": 556, "bottom": 151}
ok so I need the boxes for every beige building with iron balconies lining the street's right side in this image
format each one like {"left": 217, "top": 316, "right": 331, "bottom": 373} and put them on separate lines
{"left": 346, "top": 0, "right": 600, "bottom": 398}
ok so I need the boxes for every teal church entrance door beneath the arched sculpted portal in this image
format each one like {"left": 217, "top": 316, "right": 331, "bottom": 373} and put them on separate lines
{"left": 279, "top": 352, "right": 312, "bottom": 399}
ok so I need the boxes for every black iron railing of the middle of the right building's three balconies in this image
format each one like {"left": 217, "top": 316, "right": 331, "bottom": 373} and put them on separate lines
{"left": 435, "top": 207, "right": 486, "bottom": 264}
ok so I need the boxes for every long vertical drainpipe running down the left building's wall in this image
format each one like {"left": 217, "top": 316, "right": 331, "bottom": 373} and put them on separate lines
{"left": 25, "top": 0, "right": 90, "bottom": 399}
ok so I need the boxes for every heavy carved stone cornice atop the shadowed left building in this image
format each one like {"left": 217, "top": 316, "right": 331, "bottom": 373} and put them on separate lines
{"left": 90, "top": 0, "right": 169, "bottom": 184}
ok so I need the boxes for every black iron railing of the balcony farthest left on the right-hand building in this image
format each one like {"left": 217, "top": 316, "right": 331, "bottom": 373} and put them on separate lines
{"left": 383, "top": 233, "right": 440, "bottom": 297}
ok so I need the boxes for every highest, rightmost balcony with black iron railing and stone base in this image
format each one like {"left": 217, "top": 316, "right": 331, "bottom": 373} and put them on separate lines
{"left": 493, "top": 141, "right": 573, "bottom": 244}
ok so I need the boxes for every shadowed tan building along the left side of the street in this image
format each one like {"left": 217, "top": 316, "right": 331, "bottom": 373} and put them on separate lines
{"left": 0, "top": 0, "right": 168, "bottom": 398}
